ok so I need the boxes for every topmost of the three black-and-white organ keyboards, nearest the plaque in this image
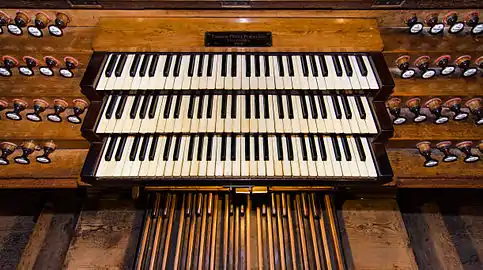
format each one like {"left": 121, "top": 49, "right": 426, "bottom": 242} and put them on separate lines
{"left": 96, "top": 53, "right": 380, "bottom": 91}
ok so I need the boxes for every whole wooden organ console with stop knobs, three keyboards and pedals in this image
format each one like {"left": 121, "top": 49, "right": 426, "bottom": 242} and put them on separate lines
{"left": 0, "top": 0, "right": 483, "bottom": 269}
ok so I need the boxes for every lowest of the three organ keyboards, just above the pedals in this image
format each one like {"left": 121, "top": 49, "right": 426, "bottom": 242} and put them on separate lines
{"left": 95, "top": 134, "right": 378, "bottom": 178}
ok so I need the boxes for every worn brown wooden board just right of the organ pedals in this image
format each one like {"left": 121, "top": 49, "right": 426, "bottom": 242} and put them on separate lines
{"left": 338, "top": 199, "right": 417, "bottom": 270}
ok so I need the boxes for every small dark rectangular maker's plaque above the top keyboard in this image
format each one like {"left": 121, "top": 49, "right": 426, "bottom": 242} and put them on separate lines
{"left": 205, "top": 31, "right": 272, "bottom": 47}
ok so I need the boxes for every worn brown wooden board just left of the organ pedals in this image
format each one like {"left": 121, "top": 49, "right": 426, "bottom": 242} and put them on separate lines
{"left": 64, "top": 196, "right": 143, "bottom": 269}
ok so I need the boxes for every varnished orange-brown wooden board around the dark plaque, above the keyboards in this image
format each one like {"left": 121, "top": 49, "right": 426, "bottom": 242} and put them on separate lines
{"left": 92, "top": 18, "right": 383, "bottom": 52}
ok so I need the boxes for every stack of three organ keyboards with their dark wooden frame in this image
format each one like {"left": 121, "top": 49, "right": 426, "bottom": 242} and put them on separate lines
{"left": 81, "top": 17, "right": 394, "bottom": 186}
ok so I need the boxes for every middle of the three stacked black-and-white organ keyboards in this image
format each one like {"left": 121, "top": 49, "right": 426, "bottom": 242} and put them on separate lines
{"left": 95, "top": 94, "right": 378, "bottom": 134}
